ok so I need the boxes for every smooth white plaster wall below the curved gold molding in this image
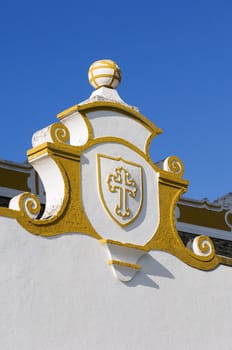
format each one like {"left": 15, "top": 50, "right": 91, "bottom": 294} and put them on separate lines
{"left": 0, "top": 217, "right": 232, "bottom": 350}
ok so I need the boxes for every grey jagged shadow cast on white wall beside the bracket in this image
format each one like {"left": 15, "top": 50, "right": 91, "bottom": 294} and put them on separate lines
{"left": 125, "top": 254, "right": 175, "bottom": 289}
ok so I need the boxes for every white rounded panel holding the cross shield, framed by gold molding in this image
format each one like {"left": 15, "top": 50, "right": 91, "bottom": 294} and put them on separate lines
{"left": 81, "top": 140, "right": 160, "bottom": 246}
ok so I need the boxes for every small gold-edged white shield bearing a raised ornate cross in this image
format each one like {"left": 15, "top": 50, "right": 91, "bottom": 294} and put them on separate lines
{"left": 97, "top": 154, "right": 143, "bottom": 226}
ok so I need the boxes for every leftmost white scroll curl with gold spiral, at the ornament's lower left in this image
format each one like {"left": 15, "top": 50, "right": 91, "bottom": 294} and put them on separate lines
{"left": 9, "top": 192, "right": 41, "bottom": 219}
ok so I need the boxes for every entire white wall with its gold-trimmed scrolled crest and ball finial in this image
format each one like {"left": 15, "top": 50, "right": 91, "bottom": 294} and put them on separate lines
{"left": 0, "top": 60, "right": 232, "bottom": 350}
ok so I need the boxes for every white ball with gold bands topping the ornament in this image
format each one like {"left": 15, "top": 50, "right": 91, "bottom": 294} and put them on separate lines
{"left": 88, "top": 60, "right": 121, "bottom": 89}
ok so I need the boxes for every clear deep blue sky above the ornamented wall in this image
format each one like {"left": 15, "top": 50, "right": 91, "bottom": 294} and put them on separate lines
{"left": 0, "top": 0, "right": 232, "bottom": 200}
